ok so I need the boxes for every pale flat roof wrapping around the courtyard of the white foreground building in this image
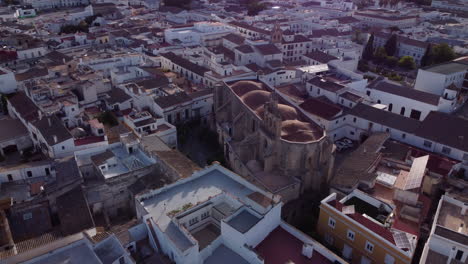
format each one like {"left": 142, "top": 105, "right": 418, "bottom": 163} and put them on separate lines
{"left": 137, "top": 164, "right": 279, "bottom": 252}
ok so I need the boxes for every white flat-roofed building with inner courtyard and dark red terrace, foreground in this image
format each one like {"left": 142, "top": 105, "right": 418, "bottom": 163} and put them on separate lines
{"left": 136, "top": 164, "right": 345, "bottom": 264}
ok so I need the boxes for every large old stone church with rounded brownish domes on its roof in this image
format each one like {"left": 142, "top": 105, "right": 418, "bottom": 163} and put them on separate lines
{"left": 214, "top": 80, "right": 334, "bottom": 202}
